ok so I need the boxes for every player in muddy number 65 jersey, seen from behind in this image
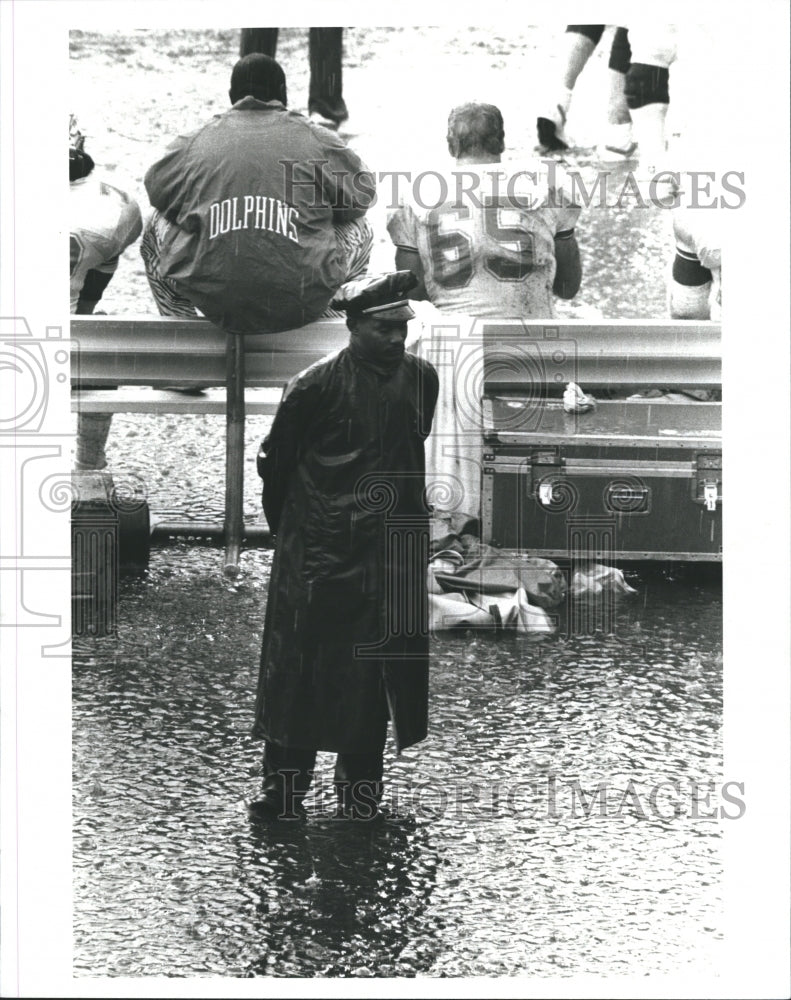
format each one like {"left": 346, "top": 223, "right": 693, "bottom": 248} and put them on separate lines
{"left": 388, "top": 104, "right": 582, "bottom": 319}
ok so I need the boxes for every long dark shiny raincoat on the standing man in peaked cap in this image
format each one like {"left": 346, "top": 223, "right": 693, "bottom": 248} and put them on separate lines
{"left": 253, "top": 347, "right": 438, "bottom": 753}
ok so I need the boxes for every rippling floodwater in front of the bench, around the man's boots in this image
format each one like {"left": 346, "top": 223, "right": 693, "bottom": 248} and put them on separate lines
{"left": 73, "top": 545, "right": 724, "bottom": 977}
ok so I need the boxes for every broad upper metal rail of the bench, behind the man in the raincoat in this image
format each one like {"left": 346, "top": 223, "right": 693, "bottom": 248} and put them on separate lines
{"left": 71, "top": 316, "right": 721, "bottom": 388}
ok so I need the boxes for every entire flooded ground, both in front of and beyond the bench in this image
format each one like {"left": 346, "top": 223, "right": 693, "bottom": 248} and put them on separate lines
{"left": 71, "top": 26, "right": 724, "bottom": 977}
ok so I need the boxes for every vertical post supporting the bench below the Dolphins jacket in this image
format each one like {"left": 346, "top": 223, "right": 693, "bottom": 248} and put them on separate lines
{"left": 224, "top": 334, "right": 244, "bottom": 576}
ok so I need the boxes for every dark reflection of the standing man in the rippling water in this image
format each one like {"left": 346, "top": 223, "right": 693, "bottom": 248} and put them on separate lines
{"left": 239, "top": 819, "right": 439, "bottom": 976}
